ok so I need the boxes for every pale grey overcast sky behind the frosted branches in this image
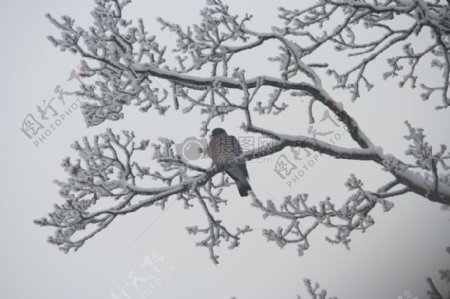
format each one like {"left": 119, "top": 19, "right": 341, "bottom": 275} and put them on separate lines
{"left": 0, "top": 0, "right": 450, "bottom": 299}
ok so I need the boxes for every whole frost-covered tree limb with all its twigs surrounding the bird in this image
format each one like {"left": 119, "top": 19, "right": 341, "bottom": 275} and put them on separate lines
{"left": 36, "top": 0, "right": 450, "bottom": 263}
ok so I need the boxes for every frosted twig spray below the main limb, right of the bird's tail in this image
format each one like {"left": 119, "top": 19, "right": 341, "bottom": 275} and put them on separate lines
{"left": 253, "top": 175, "right": 402, "bottom": 256}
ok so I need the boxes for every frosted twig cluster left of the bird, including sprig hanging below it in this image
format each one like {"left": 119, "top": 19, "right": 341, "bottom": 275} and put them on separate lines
{"left": 35, "top": 130, "right": 250, "bottom": 262}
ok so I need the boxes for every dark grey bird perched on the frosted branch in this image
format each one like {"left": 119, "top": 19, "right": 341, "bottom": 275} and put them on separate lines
{"left": 208, "top": 128, "right": 252, "bottom": 196}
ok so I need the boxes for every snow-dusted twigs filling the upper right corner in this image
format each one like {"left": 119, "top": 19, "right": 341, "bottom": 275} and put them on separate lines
{"left": 277, "top": 0, "right": 450, "bottom": 109}
